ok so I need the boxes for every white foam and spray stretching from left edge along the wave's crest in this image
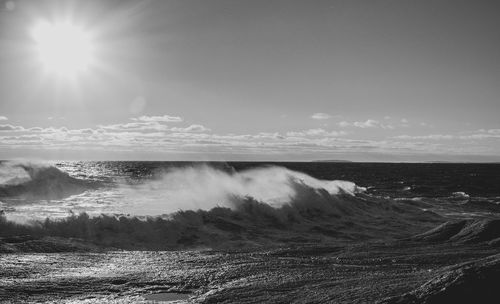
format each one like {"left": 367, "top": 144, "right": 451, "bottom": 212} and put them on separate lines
{"left": 0, "top": 165, "right": 366, "bottom": 220}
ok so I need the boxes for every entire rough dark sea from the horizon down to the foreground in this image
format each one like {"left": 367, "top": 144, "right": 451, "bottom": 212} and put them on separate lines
{"left": 0, "top": 161, "right": 500, "bottom": 303}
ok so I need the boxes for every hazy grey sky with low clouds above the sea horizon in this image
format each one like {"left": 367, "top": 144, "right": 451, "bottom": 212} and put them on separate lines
{"left": 0, "top": 0, "right": 500, "bottom": 162}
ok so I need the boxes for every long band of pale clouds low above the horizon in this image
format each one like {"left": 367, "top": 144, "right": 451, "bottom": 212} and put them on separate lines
{"left": 0, "top": 119, "right": 500, "bottom": 155}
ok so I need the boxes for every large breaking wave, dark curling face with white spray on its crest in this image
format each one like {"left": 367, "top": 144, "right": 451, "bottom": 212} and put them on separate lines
{"left": 0, "top": 166, "right": 442, "bottom": 251}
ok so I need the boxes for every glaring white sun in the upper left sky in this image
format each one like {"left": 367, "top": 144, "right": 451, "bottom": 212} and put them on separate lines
{"left": 32, "top": 22, "right": 94, "bottom": 76}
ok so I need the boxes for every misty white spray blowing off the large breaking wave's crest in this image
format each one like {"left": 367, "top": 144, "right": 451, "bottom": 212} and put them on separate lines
{"left": 121, "top": 165, "right": 365, "bottom": 215}
